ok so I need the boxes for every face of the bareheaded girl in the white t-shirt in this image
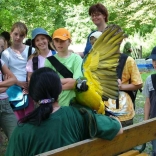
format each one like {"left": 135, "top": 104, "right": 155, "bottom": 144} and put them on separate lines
{"left": 10, "top": 28, "right": 26, "bottom": 45}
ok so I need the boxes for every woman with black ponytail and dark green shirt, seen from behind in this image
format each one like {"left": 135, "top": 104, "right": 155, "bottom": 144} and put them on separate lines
{"left": 6, "top": 67, "right": 123, "bottom": 156}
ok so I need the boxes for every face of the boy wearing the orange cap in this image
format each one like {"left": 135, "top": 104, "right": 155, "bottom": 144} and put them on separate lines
{"left": 53, "top": 38, "right": 71, "bottom": 53}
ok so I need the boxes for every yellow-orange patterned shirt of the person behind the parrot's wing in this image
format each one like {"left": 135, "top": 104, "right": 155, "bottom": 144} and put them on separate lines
{"left": 105, "top": 57, "right": 142, "bottom": 121}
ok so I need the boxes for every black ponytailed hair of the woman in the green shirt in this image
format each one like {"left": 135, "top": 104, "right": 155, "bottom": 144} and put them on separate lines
{"left": 19, "top": 67, "right": 62, "bottom": 125}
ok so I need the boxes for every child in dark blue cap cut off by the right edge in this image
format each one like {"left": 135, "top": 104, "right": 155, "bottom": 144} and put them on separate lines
{"left": 143, "top": 47, "right": 156, "bottom": 156}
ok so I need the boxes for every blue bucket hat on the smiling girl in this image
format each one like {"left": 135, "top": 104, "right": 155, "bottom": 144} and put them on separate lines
{"left": 31, "top": 28, "right": 52, "bottom": 46}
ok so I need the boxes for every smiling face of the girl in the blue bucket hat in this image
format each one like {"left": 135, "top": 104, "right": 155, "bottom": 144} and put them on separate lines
{"left": 34, "top": 35, "right": 49, "bottom": 51}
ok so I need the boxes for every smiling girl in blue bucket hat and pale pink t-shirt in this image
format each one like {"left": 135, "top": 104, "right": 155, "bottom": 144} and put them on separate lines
{"left": 26, "top": 28, "right": 56, "bottom": 82}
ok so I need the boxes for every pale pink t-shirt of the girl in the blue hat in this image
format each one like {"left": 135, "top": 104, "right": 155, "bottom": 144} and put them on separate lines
{"left": 26, "top": 51, "right": 52, "bottom": 73}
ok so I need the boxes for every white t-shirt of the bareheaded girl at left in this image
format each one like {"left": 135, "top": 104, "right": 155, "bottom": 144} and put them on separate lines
{"left": 1, "top": 46, "right": 35, "bottom": 81}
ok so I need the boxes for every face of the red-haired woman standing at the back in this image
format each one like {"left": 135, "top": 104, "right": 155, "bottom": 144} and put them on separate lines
{"left": 91, "top": 12, "right": 105, "bottom": 26}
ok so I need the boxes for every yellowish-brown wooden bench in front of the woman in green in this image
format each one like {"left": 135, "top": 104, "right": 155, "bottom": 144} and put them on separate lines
{"left": 38, "top": 118, "right": 156, "bottom": 156}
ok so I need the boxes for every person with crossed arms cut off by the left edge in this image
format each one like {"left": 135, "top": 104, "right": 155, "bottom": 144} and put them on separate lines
{"left": 0, "top": 36, "right": 17, "bottom": 140}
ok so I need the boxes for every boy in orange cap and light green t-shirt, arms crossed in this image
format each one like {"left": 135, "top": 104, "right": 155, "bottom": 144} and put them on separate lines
{"left": 45, "top": 28, "right": 82, "bottom": 106}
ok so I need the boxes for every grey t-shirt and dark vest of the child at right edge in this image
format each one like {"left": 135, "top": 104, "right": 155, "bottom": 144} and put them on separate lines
{"left": 142, "top": 75, "right": 156, "bottom": 118}
